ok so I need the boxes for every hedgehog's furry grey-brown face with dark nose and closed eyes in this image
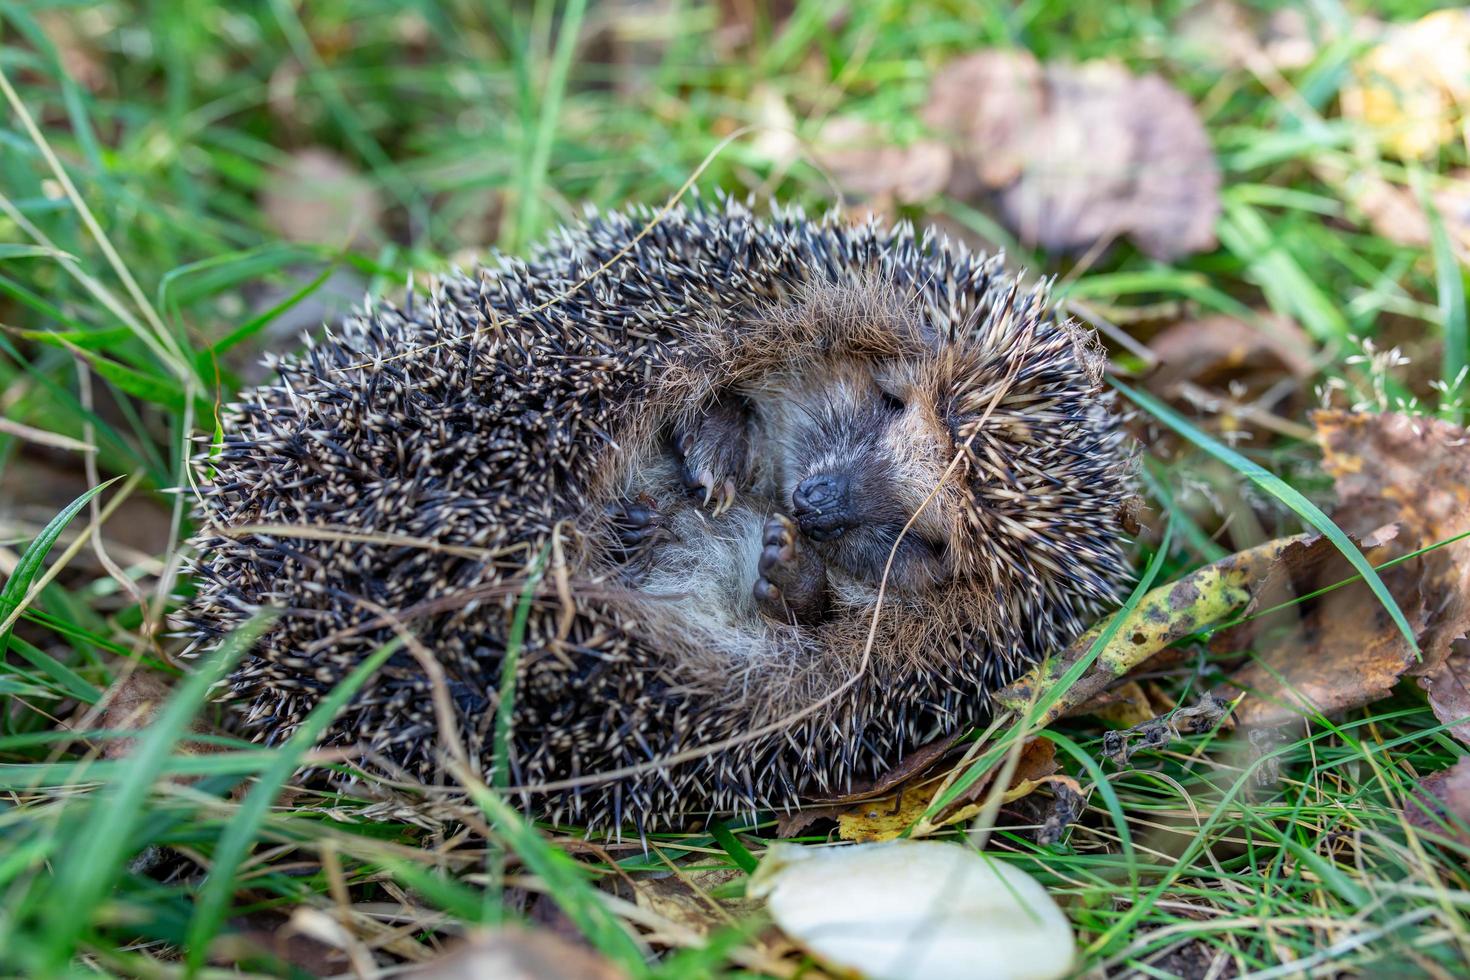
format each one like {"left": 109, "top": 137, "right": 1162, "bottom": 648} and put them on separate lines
{"left": 757, "top": 359, "right": 956, "bottom": 592}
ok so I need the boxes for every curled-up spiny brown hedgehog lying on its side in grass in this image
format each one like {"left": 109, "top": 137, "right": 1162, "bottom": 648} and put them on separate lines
{"left": 184, "top": 204, "right": 1132, "bottom": 833}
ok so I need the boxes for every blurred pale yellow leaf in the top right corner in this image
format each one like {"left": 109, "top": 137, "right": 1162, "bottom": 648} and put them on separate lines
{"left": 1341, "top": 9, "right": 1470, "bottom": 160}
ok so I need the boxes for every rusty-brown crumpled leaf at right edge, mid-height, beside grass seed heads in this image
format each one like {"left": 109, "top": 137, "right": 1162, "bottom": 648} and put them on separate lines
{"left": 1313, "top": 411, "right": 1470, "bottom": 742}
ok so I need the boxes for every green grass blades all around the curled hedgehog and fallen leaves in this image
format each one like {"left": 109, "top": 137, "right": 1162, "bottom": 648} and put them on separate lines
{"left": 0, "top": 0, "right": 1470, "bottom": 977}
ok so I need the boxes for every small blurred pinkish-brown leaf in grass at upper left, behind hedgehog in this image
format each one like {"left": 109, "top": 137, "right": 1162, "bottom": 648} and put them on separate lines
{"left": 260, "top": 148, "right": 384, "bottom": 248}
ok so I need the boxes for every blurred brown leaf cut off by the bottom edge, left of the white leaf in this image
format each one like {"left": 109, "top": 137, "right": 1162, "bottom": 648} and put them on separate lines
{"left": 404, "top": 927, "right": 625, "bottom": 980}
